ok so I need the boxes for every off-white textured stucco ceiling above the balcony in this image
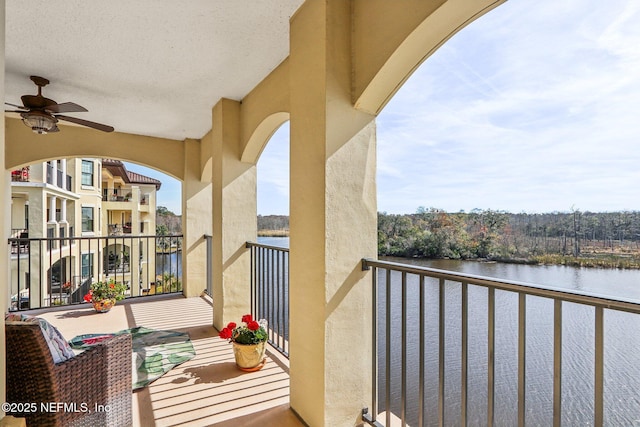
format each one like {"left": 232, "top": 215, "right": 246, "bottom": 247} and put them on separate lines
{"left": 5, "top": 0, "right": 303, "bottom": 140}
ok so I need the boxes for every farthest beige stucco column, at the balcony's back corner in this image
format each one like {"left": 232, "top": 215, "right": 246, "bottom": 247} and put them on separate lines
{"left": 182, "top": 139, "right": 212, "bottom": 297}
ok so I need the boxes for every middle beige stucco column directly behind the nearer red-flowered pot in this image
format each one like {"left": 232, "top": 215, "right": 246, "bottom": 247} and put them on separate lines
{"left": 211, "top": 99, "right": 257, "bottom": 329}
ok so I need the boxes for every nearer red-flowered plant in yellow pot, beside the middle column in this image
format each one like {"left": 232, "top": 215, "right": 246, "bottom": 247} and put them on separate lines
{"left": 220, "top": 314, "right": 268, "bottom": 372}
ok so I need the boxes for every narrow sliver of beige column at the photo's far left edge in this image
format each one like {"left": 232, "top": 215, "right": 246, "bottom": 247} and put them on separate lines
{"left": 0, "top": 0, "right": 11, "bottom": 412}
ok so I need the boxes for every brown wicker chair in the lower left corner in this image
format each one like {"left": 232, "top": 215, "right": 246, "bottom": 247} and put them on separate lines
{"left": 5, "top": 323, "right": 132, "bottom": 427}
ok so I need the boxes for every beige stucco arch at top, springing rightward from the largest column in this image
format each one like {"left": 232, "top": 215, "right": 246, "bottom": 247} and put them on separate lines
{"left": 353, "top": 0, "right": 506, "bottom": 114}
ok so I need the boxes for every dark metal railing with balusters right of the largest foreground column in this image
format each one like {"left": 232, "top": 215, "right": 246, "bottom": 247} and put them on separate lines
{"left": 362, "top": 259, "right": 640, "bottom": 427}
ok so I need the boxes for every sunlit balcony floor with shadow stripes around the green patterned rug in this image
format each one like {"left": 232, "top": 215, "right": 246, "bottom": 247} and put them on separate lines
{"left": 17, "top": 295, "right": 303, "bottom": 427}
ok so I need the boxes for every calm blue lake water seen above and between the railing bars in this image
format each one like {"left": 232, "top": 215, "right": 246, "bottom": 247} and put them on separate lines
{"left": 259, "top": 238, "right": 640, "bottom": 426}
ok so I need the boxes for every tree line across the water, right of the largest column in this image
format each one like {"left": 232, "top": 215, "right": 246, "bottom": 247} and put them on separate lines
{"left": 378, "top": 208, "right": 640, "bottom": 259}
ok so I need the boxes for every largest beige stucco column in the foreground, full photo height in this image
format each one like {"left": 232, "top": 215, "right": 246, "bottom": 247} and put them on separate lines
{"left": 290, "top": 0, "right": 377, "bottom": 427}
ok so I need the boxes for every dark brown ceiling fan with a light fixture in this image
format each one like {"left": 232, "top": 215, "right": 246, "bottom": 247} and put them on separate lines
{"left": 5, "top": 76, "right": 113, "bottom": 134}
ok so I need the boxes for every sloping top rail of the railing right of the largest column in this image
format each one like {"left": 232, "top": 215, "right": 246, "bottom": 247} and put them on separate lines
{"left": 362, "top": 258, "right": 640, "bottom": 314}
